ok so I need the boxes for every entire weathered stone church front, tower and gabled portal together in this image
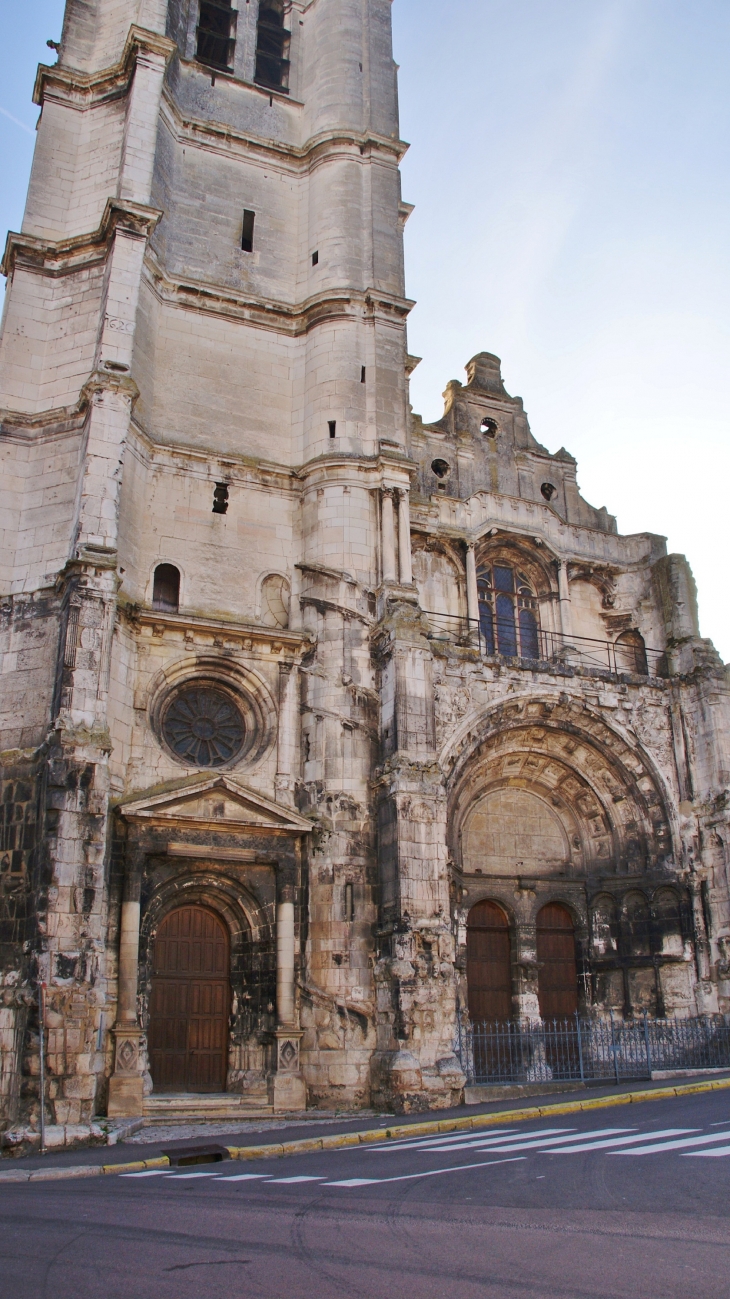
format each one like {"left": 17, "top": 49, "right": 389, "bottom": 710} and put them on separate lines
{"left": 0, "top": 0, "right": 730, "bottom": 1135}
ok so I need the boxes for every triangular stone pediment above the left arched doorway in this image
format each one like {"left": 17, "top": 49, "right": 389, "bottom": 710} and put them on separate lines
{"left": 120, "top": 776, "right": 313, "bottom": 834}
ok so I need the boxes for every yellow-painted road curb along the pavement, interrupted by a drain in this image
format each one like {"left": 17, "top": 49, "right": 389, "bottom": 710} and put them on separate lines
{"left": 0, "top": 1078, "right": 730, "bottom": 1186}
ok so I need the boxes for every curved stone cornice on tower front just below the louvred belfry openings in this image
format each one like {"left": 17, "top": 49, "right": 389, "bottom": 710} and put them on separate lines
{"left": 161, "top": 87, "right": 413, "bottom": 168}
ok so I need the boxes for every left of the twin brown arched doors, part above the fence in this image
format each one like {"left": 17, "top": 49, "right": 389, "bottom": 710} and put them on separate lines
{"left": 466, "top": 902, "right": 512, "bottom": 1024}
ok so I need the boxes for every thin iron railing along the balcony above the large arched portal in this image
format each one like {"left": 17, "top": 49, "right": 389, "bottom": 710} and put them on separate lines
{"left": 423, "top": 609, "right": 666, "bottom": 677}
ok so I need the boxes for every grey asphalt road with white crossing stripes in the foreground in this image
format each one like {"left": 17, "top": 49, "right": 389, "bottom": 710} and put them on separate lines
{"left": 0, "top": 1092, "right": 730, "bottom": 1299}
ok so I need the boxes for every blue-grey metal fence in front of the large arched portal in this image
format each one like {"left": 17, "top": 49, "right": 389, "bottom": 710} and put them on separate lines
{"left": 457, "top": 1015, "right": 730, "bottom": 1083}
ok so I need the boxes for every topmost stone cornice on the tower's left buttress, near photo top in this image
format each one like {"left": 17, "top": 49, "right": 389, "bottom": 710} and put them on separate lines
{"left": 32, "top": 25, "right": 177, "bottom": 109}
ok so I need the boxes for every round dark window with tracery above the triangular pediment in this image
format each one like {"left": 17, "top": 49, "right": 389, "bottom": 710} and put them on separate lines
{"left": 162, "top": 685, "right": 245, "bottom": 766}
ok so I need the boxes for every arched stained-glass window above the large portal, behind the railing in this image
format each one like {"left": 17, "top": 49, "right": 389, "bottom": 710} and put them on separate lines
{"left": 478, "top": 562, "right": 540, "bottom": 659}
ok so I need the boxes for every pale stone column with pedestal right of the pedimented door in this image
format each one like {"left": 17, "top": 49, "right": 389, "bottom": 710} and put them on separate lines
{"left": 270, "top": 885, "right": 307, "bottom": 1113}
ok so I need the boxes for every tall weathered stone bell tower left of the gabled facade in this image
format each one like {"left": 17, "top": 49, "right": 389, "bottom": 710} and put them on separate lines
{"left": 0, "top": 0, "right": 461, "bottom": 1128}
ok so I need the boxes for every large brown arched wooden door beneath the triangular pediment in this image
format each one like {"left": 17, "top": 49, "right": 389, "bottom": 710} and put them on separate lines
{"left": 149, "top": 907, "right": 231, "bottom": 1091}
